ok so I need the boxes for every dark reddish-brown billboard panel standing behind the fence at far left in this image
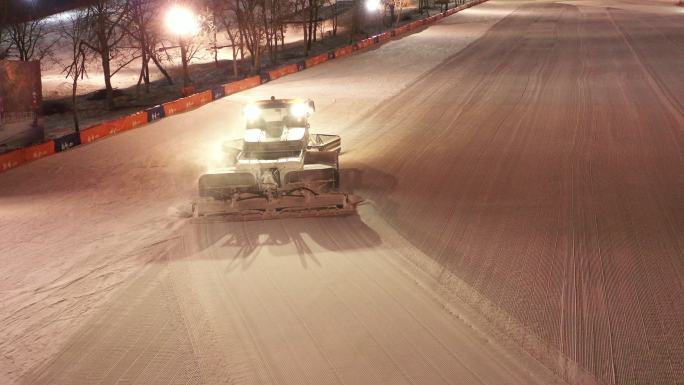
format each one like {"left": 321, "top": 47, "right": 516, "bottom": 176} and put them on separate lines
{"left": 0, "top": 60, "right": 43, "bottom": 153}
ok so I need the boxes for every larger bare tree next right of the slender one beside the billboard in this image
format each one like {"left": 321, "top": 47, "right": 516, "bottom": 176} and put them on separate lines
{"left": 83, "top": 0, "right": 135, "bottom": 110}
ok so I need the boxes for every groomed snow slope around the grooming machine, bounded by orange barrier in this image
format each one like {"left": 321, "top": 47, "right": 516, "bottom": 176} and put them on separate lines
{"left": 0, "top": 0, "right": 684, "bottom": 384}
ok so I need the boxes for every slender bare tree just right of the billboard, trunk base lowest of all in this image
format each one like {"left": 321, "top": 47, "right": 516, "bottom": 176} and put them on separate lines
{"left": 60, "top": 11, "right": 89, "bottom": 132}
